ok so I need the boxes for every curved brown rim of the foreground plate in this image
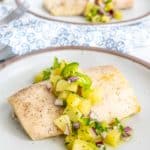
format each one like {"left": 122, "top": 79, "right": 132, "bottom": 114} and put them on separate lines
{"left": 0, "top": 46, "right": 150, "bottom": 70}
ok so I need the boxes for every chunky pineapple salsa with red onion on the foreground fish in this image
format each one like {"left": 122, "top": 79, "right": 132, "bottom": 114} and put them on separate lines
{"left": 34, "top": 58, "right": 132, "bottom": 150}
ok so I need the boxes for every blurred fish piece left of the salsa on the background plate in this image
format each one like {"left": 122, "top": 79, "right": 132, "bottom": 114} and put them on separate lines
{"left": 43, "top": 0, "right": 87, "bottom": 16}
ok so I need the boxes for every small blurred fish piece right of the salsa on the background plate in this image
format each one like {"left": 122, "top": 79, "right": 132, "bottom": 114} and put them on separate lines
{"left": 113, "top": 0, "right": 134, "bottom": 9}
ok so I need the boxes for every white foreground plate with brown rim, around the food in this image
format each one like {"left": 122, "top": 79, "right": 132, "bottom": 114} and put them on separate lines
{"left": 0, "top": 48, "right": 150, "bottom": 150}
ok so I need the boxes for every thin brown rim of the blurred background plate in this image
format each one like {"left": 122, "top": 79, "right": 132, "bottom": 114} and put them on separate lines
{"left": 15, "top": 0, "right": 150, "bottom": 26}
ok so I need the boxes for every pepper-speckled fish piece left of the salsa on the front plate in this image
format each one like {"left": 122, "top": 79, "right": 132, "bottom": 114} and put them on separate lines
{"left": 9, "top": 82, "right": 63, "bottom": 140}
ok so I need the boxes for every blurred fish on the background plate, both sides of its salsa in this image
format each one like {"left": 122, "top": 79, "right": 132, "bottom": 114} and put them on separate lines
{"left": 43, "top": 0, "right": 134, "bottom": 16}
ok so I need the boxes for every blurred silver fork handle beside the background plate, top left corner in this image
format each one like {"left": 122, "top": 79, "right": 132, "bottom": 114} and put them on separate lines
{"left": 0, "top": 0, "right": 29, "bottom": 26}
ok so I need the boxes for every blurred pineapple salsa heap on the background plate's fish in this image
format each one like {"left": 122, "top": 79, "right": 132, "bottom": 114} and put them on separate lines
{"left": 84, "top": 0, "right": 122, "bottom": 23}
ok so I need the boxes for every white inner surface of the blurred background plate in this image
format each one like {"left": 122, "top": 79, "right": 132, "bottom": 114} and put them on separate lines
{"left": 16, "top": 0, "right": 150, "bottom": 24}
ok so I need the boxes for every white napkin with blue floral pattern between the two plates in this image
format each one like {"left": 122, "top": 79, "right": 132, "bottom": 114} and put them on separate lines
{"left": 0, "top": 5, "right": 150, "bottom": 59}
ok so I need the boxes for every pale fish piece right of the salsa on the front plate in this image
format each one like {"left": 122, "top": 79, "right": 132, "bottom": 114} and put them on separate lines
{"left": 86, "top": 66, "right": 140, "bottom": 122}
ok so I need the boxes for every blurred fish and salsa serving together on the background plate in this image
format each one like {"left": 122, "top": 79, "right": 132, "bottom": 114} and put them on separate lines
{"left": 43, "top": 0, "right": 133, "bottom": 23}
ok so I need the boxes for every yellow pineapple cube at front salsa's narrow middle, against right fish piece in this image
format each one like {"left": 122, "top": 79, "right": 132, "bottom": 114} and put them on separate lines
{"left": 78, "top": 99, "right": 92, "bottom": 116}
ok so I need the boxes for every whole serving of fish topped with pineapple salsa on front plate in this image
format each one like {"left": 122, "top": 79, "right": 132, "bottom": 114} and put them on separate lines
{"left": 9, "top": 58, "right": 140, "bottom": 150}
